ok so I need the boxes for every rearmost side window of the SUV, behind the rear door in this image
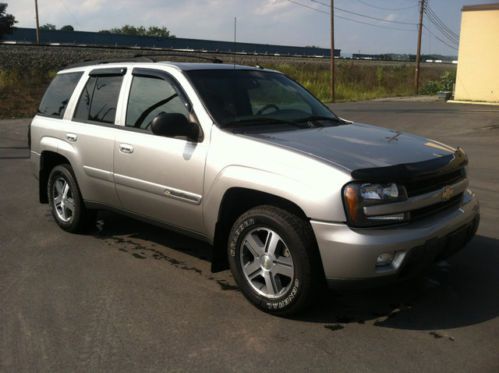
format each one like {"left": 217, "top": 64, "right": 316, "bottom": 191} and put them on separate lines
{"left": 38, "top": 72, "right": 83, "bottom": 118}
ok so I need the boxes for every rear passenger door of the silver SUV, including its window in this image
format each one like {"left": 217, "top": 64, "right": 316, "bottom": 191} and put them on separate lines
{"left": 65, "top": 68, "right": 126, "bottom": 208}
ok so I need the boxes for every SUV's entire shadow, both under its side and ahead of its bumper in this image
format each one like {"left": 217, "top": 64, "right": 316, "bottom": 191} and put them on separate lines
{"left": 93, "top": 212, "right": 499, "bottom": 330}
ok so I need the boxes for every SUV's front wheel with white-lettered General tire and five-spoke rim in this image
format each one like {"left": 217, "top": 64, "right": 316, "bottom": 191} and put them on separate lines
{"left": 227, "top": 205, "right": 323, "bottom": 316}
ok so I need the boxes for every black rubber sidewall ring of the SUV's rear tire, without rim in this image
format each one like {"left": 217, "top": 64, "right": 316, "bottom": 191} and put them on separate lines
{"left": 47, "top": 165, "right": 83, "bottom": 232}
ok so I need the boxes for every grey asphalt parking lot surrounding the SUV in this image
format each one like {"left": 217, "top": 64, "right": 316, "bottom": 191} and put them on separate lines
{"left": 0, "top": 102, "right": 499, "bottom": 372}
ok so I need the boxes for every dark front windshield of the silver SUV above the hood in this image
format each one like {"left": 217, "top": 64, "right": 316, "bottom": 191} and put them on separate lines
{"left": 186, "top": 69, "right": 339, "bottom": 127}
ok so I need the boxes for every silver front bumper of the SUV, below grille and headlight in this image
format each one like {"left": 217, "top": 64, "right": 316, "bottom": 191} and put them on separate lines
{"left": 311, "top": 190, "right": 480, "bottom": 286}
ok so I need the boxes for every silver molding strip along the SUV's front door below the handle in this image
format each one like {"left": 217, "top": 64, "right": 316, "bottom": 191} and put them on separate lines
{"left": 114, "top": 174, "right": 202, "bottom": 205}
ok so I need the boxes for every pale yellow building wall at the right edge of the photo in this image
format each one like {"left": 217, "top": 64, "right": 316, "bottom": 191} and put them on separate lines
{"left": 454, "top": 3, "right": 499, "bottom": 104}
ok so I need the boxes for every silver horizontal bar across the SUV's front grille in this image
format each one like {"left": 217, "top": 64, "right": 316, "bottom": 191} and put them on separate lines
{"left": 364, "top": 179, "right": 468, "bottom": 216}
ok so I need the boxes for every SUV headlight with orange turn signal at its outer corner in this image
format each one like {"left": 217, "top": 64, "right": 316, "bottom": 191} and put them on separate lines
{"left": 343, "top": 182, "right": 408, "bottom": 227}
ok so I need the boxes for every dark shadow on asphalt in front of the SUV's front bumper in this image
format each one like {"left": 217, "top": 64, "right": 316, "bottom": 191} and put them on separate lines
{"left": 299, "top": 235, "right": 499, "bottom": 330}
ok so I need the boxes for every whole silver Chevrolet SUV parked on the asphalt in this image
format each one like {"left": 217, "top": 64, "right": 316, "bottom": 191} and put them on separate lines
{"left": 30, "top": 62, "right": 479, "bottom": 315}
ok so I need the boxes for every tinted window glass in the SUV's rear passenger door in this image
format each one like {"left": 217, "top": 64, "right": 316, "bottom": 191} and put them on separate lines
{"left": 74, "top": 75, "right": 123, "bottom": 123}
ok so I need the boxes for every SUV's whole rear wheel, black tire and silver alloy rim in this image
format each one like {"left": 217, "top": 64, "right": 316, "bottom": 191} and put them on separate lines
{"left": 47, "top": 164, "right": 94, "bottom": 233}
